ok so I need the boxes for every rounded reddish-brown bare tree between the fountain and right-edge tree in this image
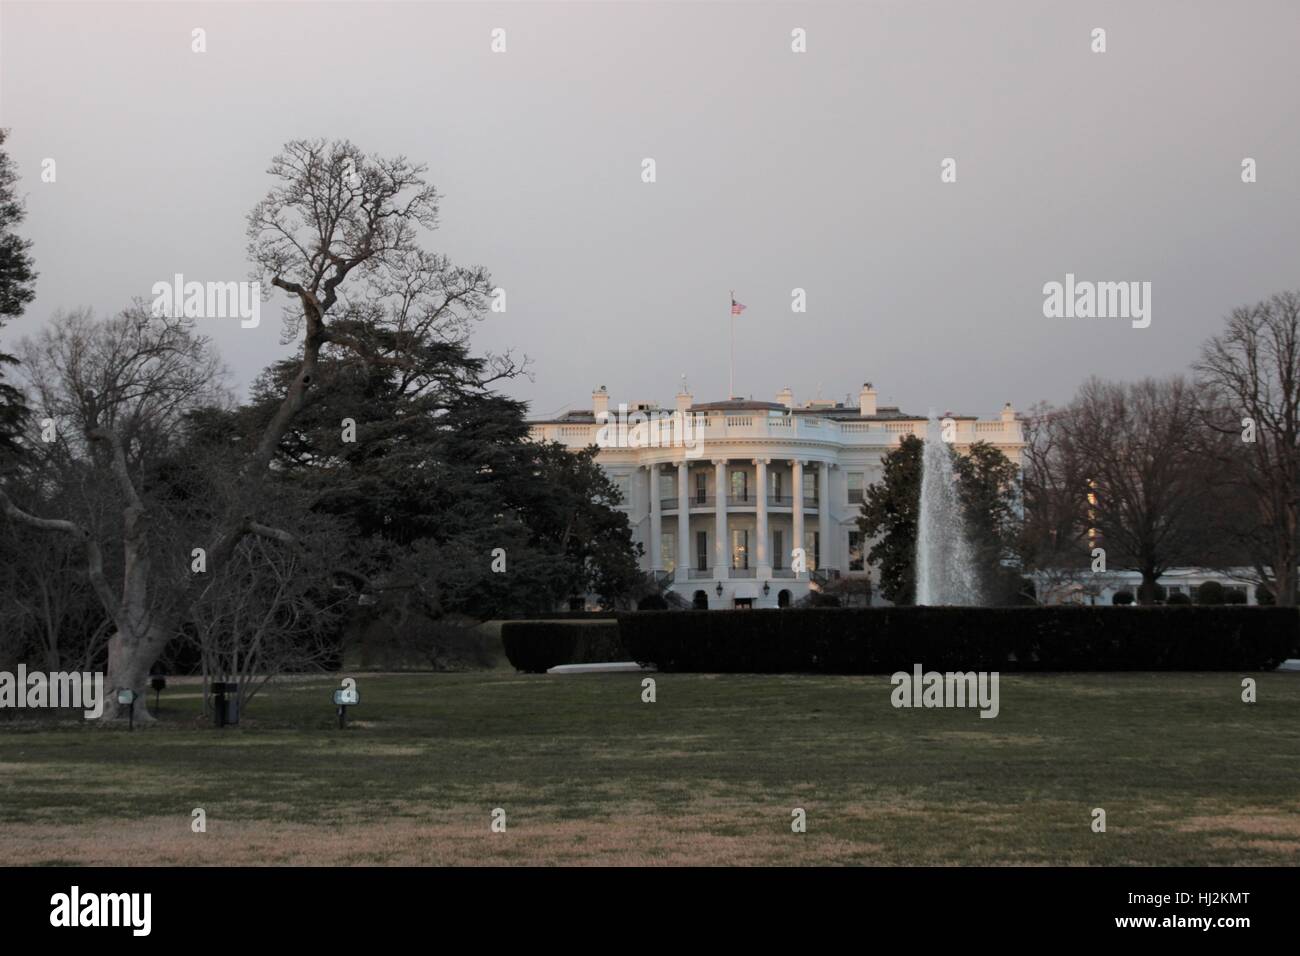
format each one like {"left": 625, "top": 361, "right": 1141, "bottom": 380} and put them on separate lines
{"left": 1058, "top": 377, "right": 1210, "bottom": 604}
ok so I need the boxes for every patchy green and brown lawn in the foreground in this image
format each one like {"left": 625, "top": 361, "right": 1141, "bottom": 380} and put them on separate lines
{"left": 0, "top": 671, "right": 1300, "bottom": 865}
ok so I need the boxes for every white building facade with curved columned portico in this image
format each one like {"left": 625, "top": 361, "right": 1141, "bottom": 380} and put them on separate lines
{"left": 529, "top": 384, "right": 1024, "bottom": 607}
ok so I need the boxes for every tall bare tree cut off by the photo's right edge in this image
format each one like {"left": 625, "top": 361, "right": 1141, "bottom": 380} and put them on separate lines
{"left": 1195, "top": 291, "right": 1300, "bottom": 605}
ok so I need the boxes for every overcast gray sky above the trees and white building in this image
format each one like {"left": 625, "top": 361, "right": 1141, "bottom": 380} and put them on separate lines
{"left": 0, "top": 0, "right": 1300, "bottom": 415}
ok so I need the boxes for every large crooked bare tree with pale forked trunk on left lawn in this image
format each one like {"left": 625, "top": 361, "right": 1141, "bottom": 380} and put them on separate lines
{"left": 0, "top": 140, "right": 496, "bottom": 717}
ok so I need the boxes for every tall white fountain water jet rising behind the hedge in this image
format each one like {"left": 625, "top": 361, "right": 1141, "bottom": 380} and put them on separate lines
{"left": 917, "top": 414, "right": 982, "bottom": 605}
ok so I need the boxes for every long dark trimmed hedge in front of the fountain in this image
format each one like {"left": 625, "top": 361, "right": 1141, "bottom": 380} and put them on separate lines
{"left": 619, "top": 606, "right": 1300, "bottom": 674}
